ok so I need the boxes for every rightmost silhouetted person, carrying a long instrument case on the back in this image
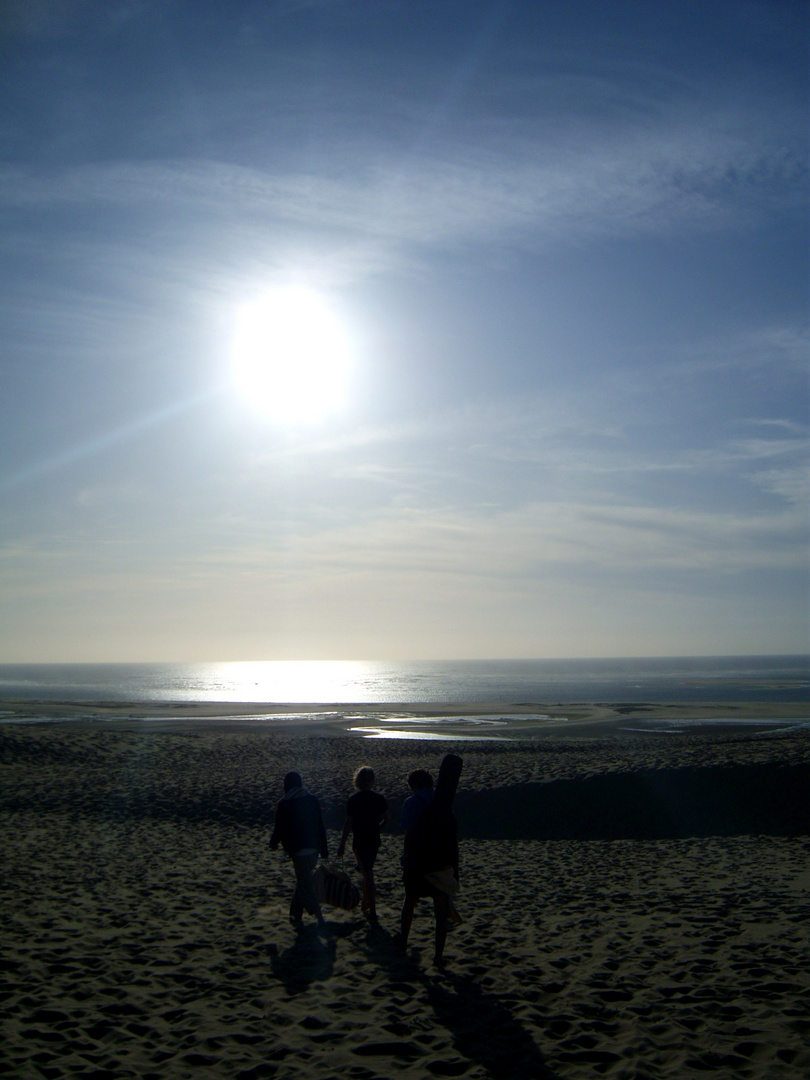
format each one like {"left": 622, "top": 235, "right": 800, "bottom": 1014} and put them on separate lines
{"left": 400, "top": 769, "right": 458, "bottom": 964}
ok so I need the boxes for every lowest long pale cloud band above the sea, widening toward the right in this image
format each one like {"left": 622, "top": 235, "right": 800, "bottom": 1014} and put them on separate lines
{"left": 182, "top": 494, "right": 807, "bottom": 583}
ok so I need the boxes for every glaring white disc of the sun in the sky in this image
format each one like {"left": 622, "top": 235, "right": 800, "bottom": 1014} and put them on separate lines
{"left": 232, "top": 287, "right": 351, "bottom": 422}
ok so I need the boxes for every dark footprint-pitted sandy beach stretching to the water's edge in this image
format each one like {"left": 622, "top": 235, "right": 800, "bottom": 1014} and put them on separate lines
{"left": 0, "top": 702, "right": 810, "bottom": 1080}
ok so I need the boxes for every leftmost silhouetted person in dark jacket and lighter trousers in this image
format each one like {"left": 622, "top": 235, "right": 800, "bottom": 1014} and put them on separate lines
{"left": 270, "top": 772, "right": 329, "bottom": 928}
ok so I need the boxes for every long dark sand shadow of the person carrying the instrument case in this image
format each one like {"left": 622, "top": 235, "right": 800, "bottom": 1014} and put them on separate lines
{"left": 364, "top": 929, "right": 559, "bottom": 1080}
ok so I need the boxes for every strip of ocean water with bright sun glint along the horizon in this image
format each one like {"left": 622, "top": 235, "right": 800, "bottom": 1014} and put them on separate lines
{"left": 0, "top": 656, "right": 810, "bottom": 705}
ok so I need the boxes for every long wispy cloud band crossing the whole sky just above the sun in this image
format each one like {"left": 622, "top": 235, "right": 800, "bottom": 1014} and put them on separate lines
{"left": 0, "top": 101, "right": 807, "bottom": 263}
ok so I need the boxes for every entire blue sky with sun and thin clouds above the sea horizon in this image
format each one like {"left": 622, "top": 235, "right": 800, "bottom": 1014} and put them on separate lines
{"left": 0, "top": 0, "right": 810, "bottom": 662}
